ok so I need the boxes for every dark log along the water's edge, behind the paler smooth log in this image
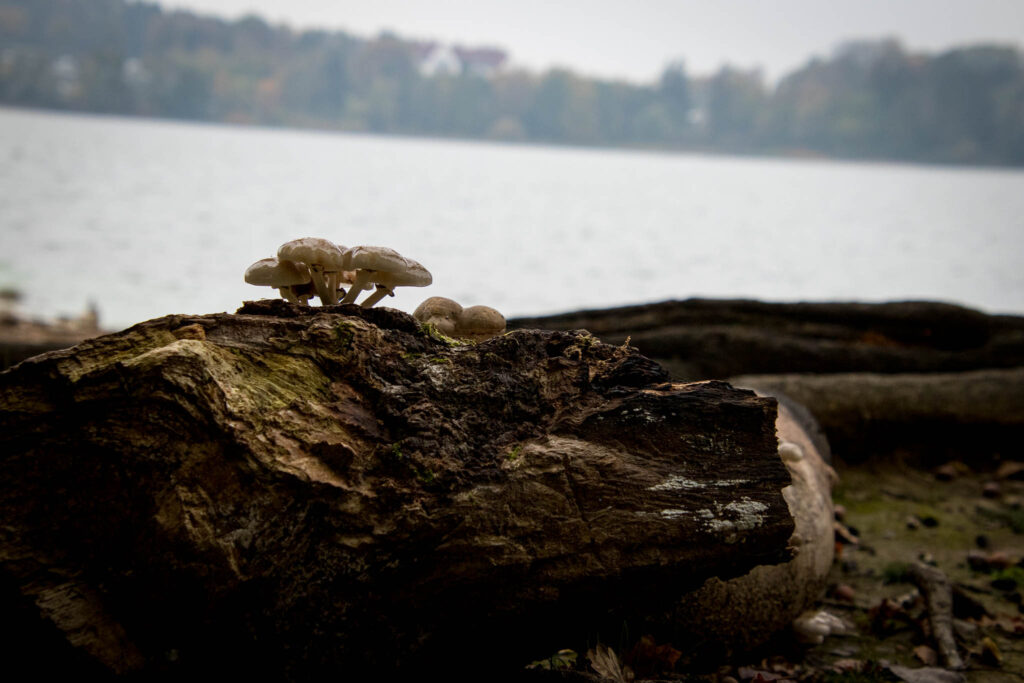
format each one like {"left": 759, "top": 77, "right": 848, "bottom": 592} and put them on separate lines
{"left": 509, "top": 299, "right": 1024, "bottom": 380}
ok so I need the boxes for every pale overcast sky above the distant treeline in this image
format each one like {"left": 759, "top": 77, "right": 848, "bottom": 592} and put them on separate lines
{"left": 160, "top": 0, "right": 1024, "bottom": 81}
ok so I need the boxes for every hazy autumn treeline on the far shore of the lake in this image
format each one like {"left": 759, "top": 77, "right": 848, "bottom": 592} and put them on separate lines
{"left": 0, "top": 0, "right": 1024, "bottom": 165}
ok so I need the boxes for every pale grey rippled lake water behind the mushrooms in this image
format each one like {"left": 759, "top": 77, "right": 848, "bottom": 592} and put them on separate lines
{"left": 0, "top": 109, "right": 1024, "bottom": 328}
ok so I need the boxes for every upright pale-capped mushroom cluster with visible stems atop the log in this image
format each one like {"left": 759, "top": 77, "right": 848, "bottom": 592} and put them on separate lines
{"left": 245, "top": 238, "right": 433, "bottom": 308}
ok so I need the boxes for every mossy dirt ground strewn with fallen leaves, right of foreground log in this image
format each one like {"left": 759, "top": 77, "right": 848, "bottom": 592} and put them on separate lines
{"left": 528, "top": 459, "right": 1024, "bottom": 683}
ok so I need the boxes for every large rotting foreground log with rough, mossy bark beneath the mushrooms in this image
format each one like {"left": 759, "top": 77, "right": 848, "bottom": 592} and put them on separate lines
{"left": 0, "top": 302, "right": 794, "bottom": 680}
